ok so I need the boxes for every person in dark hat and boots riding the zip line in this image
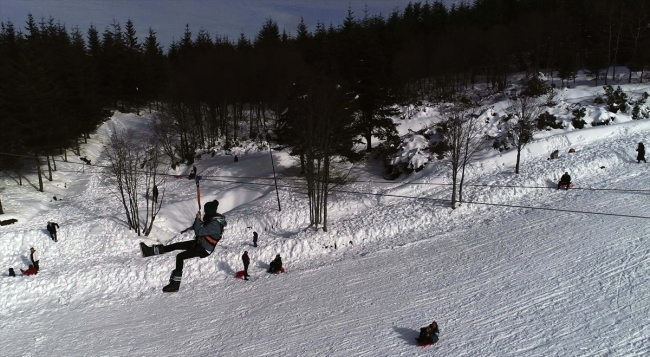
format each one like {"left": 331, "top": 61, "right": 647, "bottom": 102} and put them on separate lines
{"left": 140, "top": 200, "right": 226, "bottom": 293}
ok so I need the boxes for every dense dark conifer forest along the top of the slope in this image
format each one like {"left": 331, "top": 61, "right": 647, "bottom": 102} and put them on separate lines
{"left": 0, "top": 0, "right": 650, "bottom": 169}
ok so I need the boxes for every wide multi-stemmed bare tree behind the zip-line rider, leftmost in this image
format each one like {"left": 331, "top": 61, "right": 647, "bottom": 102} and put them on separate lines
{"left": 106, "top": 130, "right": 164, "bottom": 235}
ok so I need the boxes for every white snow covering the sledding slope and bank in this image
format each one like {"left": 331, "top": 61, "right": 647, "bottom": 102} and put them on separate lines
{"left": 0, "top": 78, "right": 650, "bottom": 357}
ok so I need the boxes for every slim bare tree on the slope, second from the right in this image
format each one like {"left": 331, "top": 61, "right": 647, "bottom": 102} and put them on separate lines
{"left": 442, "top": 105, "right": 483, "bottom": 209}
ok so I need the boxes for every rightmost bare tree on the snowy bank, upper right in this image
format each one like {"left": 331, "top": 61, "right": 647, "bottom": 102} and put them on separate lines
{"left": 507, "top": 95, "right": 543, "bottom": 174}
